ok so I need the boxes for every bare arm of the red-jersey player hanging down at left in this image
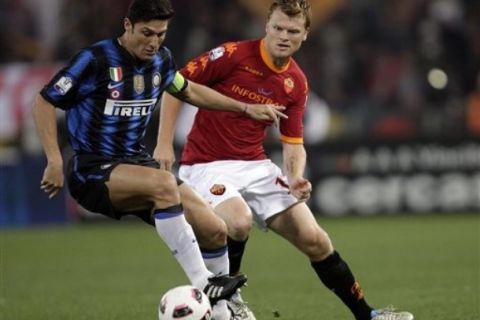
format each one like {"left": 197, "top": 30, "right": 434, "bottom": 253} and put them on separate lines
{"left": 153, "top": 92, "right": 182, "bottom": 171}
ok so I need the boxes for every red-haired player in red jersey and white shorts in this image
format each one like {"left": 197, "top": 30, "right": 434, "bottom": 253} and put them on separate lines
{"left": 154, "top": 0, "right": 413, "bottom": 320}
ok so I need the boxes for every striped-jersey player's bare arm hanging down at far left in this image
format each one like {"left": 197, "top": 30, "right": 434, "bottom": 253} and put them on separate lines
{"left": 32, "top": 94, "right": 64, "bottom": 198}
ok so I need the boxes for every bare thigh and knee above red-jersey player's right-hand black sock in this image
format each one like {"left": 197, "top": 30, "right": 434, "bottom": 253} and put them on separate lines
{"left": 267, "top": 202, "right": 333, "bottom": 260}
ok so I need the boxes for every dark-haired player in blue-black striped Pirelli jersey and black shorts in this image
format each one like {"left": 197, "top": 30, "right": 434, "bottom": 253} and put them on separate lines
{"left": 33, "top": 0, "right": 283, "bottom": 320}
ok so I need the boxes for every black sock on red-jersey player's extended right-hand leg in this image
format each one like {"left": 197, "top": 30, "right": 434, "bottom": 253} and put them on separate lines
{"left": 312, "top": 251, "right": 372, "bottom": 320}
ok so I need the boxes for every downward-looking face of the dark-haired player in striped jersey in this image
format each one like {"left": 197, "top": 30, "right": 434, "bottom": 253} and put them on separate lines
{"left": 124, "top": 19, "right": 168, "bottom": 61}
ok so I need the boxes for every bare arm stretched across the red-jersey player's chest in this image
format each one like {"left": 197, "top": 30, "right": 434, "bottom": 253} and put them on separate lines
{"left": 175, "top": 81, "right": 287, "bottom": 124}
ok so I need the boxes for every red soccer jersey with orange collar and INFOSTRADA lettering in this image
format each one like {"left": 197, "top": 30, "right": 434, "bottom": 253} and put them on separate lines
{"left": 181, "top": 40, "right": 308, "bottom": 165}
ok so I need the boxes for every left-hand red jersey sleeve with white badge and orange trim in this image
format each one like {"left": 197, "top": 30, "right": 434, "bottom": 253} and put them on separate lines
{"left": 180, "top": 42, "right": 238, "bottom": 86}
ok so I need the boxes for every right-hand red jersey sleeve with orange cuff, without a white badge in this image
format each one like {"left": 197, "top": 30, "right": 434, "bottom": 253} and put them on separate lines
{"left": 280, "top": 79, "right": 308, "bottom": 144}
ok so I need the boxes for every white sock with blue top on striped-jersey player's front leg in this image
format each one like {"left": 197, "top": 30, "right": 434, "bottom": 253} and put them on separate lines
{"left": 154, "top": 207, "right": 212, "bottom": 290}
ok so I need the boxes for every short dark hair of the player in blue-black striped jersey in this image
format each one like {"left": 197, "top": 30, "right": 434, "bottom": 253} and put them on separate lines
{"left": 127, "top": 0, "right": 175, "bottom": 24}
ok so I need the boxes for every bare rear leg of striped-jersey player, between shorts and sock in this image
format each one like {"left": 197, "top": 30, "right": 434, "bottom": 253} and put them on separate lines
{"left": 179, "top": 183, "right": 227, "bottom": 249}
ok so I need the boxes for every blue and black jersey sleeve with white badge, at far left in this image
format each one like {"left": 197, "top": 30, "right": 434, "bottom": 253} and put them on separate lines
{"left": 40, "top": 49, "right": 97, "bottom": 110}
